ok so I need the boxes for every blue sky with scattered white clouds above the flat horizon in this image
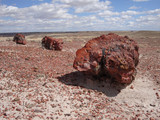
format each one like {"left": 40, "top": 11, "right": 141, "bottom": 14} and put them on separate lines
{"left": 0, "top": 0, "right": 160, "bottom": 33}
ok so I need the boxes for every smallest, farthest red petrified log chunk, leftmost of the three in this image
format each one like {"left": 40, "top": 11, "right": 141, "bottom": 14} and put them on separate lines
{"left": 13, "top": 33, "right": 27, "bottom": 45}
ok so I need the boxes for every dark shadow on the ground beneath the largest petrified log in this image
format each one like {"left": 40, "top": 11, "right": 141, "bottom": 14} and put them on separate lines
{"left": 58, "top": 71, "right": 127, "bottom": 97}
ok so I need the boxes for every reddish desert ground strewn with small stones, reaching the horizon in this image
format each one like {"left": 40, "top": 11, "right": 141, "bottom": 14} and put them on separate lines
{"left": 0, "top": 31, "right": 160, "bottom": 120}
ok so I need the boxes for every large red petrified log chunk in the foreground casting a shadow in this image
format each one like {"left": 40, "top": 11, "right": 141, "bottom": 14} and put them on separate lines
{"left": 73, "top": 33, "right": 139, "bottom": 83}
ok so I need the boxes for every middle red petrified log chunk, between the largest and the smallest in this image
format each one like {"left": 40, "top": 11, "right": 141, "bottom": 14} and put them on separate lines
{"left": 42, "top": 36, "right": 63, "bottom": 50}
